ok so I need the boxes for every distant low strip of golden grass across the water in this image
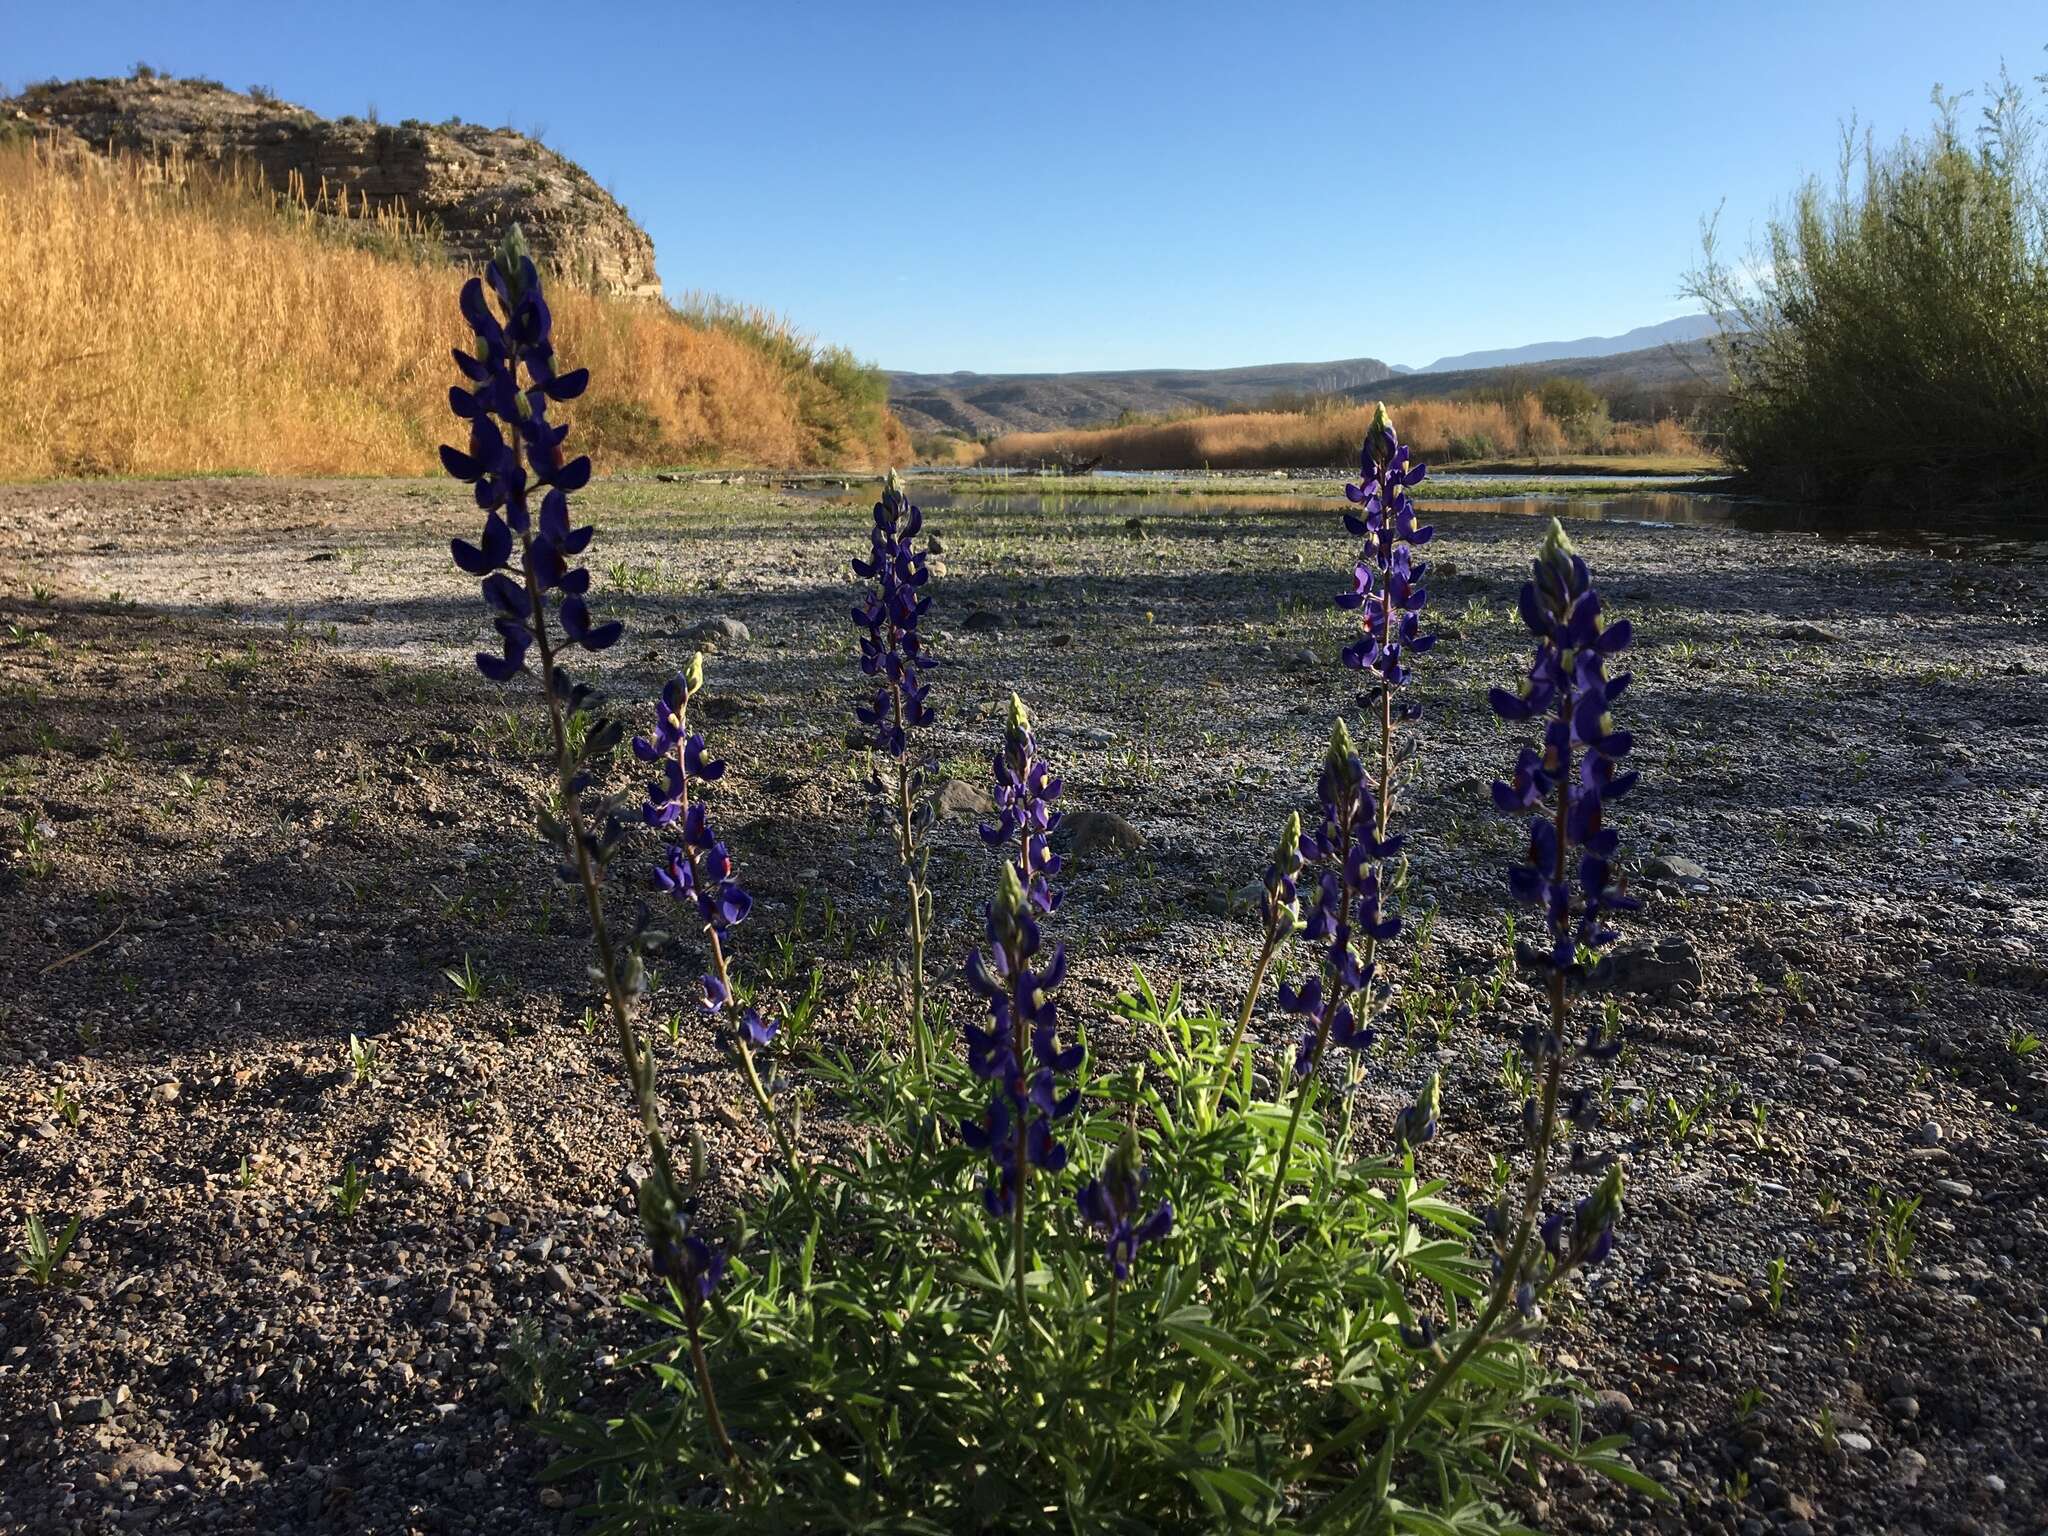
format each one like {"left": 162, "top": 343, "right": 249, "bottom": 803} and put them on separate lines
{"left": 989, "top": 395, "right": 1698, "bottom": 469}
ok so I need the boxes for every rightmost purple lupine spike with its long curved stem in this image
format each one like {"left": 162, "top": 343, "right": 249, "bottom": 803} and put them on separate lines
{"left": 1382, "top": 520, "right": 1638, "bottom": 1462}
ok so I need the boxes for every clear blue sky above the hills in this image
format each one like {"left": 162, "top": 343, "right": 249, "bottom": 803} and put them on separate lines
{"left": 16, "top": 0, "right": 2048, "bottom": 373}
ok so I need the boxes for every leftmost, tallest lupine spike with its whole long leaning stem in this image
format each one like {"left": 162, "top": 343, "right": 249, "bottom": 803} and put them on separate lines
{"left": 440, "top": 225, "right": 737, "bottom": 1462}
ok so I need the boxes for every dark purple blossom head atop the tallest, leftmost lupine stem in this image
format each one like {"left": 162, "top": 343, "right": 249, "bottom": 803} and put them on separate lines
{"left": 440, "top": 225, "right": 621, "bottom": 682}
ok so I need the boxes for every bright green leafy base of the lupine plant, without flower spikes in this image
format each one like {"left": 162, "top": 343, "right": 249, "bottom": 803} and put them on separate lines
{"left": 549, "top": 977, "right": 1653, "bottom": 1532}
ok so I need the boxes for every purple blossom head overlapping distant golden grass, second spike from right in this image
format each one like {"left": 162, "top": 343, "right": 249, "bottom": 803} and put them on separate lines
{"left": 1335, "top": 406, "right": 1436, "bottom": 715}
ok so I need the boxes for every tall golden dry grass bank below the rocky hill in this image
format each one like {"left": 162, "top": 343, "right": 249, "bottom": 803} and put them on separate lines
{"left": 0, "top": 143, "right": 909, "bottom": 479}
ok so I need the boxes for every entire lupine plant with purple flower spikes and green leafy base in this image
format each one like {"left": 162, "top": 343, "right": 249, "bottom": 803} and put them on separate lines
{"left": 446, "top": 249, "right": 1655, "bottom": 1532}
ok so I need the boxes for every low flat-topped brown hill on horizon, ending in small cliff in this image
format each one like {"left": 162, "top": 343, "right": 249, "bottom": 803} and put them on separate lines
{"left": 889, "top": 356, "right": 1393, "bottom": 436}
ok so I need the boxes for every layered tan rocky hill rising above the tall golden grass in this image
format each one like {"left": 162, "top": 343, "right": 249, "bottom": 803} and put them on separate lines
{"left": 0, "top": 74, "right": 662, "bottom": 297}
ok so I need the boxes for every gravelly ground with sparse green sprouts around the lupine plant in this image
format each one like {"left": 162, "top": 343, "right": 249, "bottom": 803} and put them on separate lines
{"left": 0, "top": 479, "right": 2048, "bottom": 1534}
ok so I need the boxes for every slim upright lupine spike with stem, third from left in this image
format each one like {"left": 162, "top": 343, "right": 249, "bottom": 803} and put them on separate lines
{"left": 854, "top": 469, "right": 938, "bottom": 1069}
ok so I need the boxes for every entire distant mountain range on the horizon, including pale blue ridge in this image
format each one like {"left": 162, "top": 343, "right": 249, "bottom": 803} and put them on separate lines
{"left": 889, "top": 315, "right": 1714, "bottom": 438}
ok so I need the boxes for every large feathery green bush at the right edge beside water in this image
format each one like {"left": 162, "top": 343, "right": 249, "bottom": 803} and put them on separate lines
{"left": 1692, "top": 78, "right": 2048, "bottom": 502}
